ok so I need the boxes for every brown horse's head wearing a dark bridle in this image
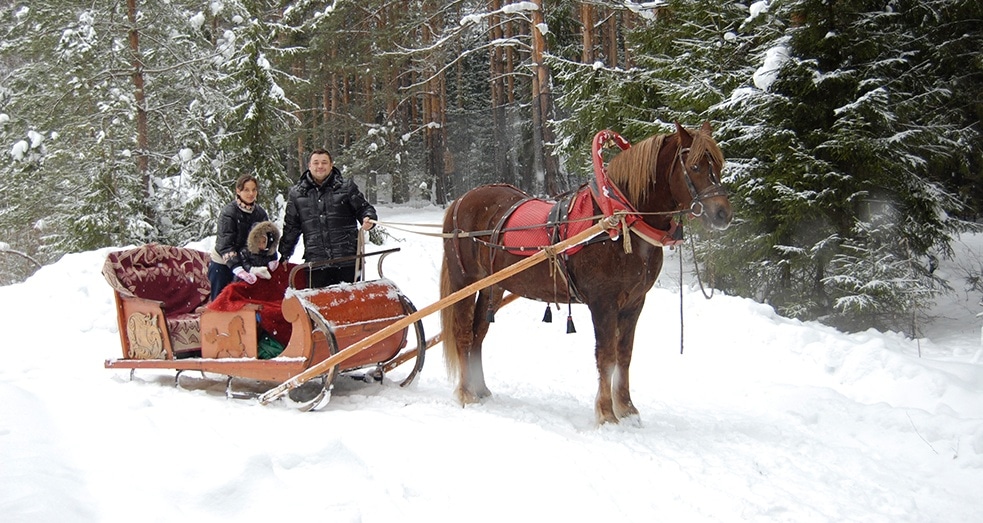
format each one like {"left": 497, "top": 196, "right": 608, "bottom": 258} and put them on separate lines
{"left": 660, "top": 122, "right": 734, "bottom": 229}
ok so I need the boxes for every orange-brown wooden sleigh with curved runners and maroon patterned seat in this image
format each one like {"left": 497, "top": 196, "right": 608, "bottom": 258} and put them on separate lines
{"left": 103, "top": 244, "right": 426, "bottom": 410}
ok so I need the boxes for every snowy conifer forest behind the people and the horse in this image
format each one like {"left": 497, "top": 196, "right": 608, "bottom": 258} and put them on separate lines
{"left": 0, "top": 0, "right": 983, "bottom": 334}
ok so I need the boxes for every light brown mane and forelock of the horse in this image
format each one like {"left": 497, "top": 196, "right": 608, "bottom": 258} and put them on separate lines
{"left": 608, "top": 129, "right": 724, "bottom": 205}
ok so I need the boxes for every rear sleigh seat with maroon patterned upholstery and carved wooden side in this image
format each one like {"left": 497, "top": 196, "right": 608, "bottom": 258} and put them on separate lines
{"left": 102, "top": 243, "right": 211, "bottom": 359}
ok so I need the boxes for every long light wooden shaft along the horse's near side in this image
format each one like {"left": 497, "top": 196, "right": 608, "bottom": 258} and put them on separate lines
{"left": 259, "top": 217, "right": 618, "bottom": 405}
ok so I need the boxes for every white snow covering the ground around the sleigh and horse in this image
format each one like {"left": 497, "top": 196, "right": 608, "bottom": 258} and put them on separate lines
{"left": 0, "top": 207, "right": 983, "bottom": 523}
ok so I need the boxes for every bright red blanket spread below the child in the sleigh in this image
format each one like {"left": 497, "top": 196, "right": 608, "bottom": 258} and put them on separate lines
{"left": 208, "top": 263, "right": 293, "bottom": 346}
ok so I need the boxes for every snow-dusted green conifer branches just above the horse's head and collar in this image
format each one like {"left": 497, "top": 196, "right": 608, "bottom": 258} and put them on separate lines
{"left": 551, "top": 0, "right": 749, "bottom": 177}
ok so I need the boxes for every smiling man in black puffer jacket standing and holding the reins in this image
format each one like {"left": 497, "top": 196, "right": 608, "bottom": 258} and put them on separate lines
{"left": 280, "top": 149, "right": 378, "bottom": 287}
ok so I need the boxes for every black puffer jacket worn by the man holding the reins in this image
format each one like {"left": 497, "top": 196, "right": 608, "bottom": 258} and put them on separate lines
{"left": 280, "top": 167, "right": 378, "bottom": 264}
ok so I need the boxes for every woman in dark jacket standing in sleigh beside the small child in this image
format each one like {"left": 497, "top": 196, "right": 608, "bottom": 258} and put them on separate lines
{"left": 208, "top": 174, "right": 278, "bottom": 300}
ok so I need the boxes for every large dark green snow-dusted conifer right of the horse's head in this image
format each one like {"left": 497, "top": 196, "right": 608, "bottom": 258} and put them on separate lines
{"left": 717, "top": 0, "right": 972, "bottom": 329}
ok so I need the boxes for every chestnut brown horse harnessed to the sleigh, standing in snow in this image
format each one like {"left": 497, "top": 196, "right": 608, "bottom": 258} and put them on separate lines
{"left": 440, "top": 122, "right": 733, "bottom": 425}
